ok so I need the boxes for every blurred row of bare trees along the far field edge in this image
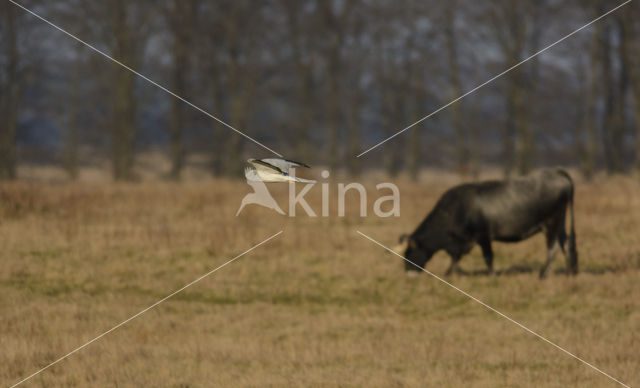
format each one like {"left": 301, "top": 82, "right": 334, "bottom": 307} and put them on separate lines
{"left": 0, "top": 0, "right": 640, "bottom": 180}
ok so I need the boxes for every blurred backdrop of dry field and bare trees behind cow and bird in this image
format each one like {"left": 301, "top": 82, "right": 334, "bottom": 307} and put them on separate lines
{"left": 0, "top": 0, "right": 640, "bottom": 388}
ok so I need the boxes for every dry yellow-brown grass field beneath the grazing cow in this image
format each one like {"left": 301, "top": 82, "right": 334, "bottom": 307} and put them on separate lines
{"left": 0, "top": 177, "right": 640, "bottom": 387}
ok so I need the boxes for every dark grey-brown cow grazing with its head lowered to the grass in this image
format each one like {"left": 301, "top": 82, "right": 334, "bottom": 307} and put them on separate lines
{"left": 394, "top": 168, "right": 578, "bottom": 278}
